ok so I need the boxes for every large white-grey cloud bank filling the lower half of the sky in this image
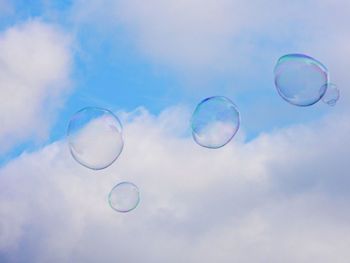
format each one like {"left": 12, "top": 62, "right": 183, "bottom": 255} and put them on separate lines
{"left": 0, "top": 107, "right": 350, "bottom": 263}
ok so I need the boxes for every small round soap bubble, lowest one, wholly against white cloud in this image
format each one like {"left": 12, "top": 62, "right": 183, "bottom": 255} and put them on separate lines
{"left": 108, "top": 182, "right": 140, "bottom": 213}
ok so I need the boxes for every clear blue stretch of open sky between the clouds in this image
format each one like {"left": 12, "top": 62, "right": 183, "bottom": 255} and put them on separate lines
{"left": 1, "top": 1, "right": 329, "bottom": 163}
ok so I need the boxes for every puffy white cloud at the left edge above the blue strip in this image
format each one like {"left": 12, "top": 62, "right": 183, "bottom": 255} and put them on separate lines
{"left": 0, "top": 20, "right": 71, "bottom": 154}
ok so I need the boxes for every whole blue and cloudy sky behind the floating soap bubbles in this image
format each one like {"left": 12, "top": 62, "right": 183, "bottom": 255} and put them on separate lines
{"left": 0, "top": 0, "right": 350, "bottom": 263}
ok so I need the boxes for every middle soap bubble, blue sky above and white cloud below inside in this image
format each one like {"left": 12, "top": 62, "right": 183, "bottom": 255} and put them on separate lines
{"left": 191, "top": 96, "right": 240, "bottom": 149}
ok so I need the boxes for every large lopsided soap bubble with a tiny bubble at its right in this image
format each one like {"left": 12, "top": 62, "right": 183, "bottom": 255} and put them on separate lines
{"left": 274, "top": 54, "right": 329, "bottom": 106}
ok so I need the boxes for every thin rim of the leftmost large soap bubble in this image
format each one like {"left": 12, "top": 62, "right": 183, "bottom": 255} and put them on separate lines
{"left": 66, "top": 106, "right": 124, "bottom": 171}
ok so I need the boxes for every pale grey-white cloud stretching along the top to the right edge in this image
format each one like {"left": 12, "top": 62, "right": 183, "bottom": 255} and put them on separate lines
{"left": 72, "top": 0, "right": 349, "bottom": 79}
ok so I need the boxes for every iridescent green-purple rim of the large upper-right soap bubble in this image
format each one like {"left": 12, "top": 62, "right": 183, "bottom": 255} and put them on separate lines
{"left": 273, "top": 53, "right": 330, "bottom": 107}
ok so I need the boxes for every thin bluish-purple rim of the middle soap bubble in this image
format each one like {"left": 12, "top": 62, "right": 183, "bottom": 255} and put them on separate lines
{"left": 190, "top": 95, "right": 241, "bottom": 149}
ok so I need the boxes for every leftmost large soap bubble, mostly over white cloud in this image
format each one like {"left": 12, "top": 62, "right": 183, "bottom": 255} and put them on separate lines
{"left": 67, "top": 107, "right": 124, "bottom": 170}
